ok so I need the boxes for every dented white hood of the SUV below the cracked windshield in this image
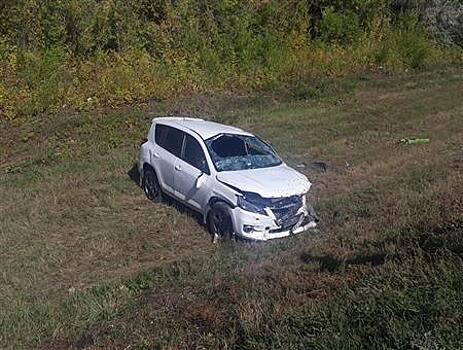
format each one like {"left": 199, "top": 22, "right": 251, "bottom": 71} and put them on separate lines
{"left": 217, "top": 164, "right": 311, "bottom": 198}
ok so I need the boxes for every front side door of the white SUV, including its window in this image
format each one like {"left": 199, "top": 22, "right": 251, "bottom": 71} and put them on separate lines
{"left": 174, "top": 133, "right": 210, "bottom": 211}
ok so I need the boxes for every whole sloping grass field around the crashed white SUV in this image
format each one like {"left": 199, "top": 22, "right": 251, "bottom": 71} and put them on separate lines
{"left": 0, "top": 68, "right": 463, "bottom": 349}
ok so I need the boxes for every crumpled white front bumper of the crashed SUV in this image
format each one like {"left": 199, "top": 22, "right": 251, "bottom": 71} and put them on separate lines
{"left": 230, "top": 206, "right": 317, "bottom": 241}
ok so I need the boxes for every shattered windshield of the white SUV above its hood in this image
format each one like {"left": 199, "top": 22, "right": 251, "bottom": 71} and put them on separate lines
{"left": 206, "top": 134, "right": 282, "bottom": 171}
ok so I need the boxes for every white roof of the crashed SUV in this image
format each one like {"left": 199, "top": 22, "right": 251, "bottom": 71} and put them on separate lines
{"left": 153, "top": 117, "right": 254, "bottom": 140}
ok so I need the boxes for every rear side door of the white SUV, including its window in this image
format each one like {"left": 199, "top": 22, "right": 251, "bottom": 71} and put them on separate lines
{"left": 152, "top": 124, "right": 184, "bottom": 195}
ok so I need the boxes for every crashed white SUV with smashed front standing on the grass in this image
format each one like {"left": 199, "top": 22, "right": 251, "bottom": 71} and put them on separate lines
{"left": 138, "top": 117, "right": 316, "bottom": 241}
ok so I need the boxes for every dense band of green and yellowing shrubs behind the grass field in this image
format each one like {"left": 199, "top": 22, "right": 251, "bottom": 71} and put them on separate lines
{"left": 0, "top": 0, "right": 461, "bottom": 119}
